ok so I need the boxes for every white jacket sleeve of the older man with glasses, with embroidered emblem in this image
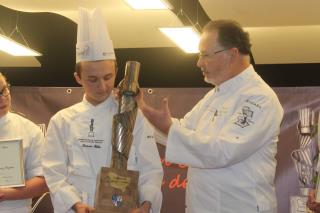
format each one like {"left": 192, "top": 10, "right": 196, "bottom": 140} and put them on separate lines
{"left": 166, "top": 96, "right": 283, "bottom": 169}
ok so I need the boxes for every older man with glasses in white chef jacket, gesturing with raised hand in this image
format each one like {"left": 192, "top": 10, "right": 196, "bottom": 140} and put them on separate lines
{"left": 137, "top": 20, "right": 283, "bottom": 213}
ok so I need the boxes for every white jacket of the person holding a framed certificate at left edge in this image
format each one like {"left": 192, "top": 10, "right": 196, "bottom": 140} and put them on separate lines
{"left": 0, "top": 112, "right": 44, "bottom": 213}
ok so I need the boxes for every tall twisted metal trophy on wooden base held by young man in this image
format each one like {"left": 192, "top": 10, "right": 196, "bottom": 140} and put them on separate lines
{"left": 95, "top": 61, "right": 140, "bottom": 213}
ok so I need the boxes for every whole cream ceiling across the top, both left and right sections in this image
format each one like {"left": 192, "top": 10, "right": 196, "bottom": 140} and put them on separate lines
{"left": 0, "top": 0, "right": 320, "bottom": 64}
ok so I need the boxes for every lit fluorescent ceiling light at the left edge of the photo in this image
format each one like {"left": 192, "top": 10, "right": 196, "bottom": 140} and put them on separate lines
{"left": 0, "top": 34, "right": 41, "bottom": 56}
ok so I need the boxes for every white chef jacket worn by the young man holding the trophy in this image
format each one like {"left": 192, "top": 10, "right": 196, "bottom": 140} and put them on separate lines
{"left": 42, "top": 95, "right": 163, "bottom": 213}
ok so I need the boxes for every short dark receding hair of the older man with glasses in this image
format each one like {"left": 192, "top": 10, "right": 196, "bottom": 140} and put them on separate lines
{"left": 202, "top": 20, "right": 251, "bottom": 55}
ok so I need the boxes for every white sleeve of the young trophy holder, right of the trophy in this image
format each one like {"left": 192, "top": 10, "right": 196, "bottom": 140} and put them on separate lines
{"left": 134, "top": 113, "right": 163, "bottom": 213}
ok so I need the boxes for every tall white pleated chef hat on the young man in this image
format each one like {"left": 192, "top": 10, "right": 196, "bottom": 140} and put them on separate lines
{"left": 76, "top": 8, "right": 116, "bottom": 63}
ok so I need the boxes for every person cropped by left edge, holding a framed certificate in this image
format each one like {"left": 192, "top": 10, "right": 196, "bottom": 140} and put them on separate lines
{"left": 0, "top": 73, "right": 48, "bottom": 213}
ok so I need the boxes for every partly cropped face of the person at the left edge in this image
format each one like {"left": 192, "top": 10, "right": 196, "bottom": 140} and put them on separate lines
{"left": 0, "top": 75, "right": 11, "bottom": 118}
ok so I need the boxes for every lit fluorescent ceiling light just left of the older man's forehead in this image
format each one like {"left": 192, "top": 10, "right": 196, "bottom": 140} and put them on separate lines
{"left": 159, "top": 27, "right": 200, "bottom": 53}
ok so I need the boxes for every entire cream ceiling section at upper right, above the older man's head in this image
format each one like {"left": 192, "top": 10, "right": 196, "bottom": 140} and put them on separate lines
{"left": 200, "top": 0, "right": 320, "bottom": 64}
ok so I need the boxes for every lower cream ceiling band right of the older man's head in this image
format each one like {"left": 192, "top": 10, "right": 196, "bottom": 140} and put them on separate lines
{"left": 246, "top": 25, "right": 320, "bottom": 64}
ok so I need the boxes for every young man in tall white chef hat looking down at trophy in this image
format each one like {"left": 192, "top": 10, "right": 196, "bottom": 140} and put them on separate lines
{"left": 43, "top": 9, "right": 163, "bottom": 213}
